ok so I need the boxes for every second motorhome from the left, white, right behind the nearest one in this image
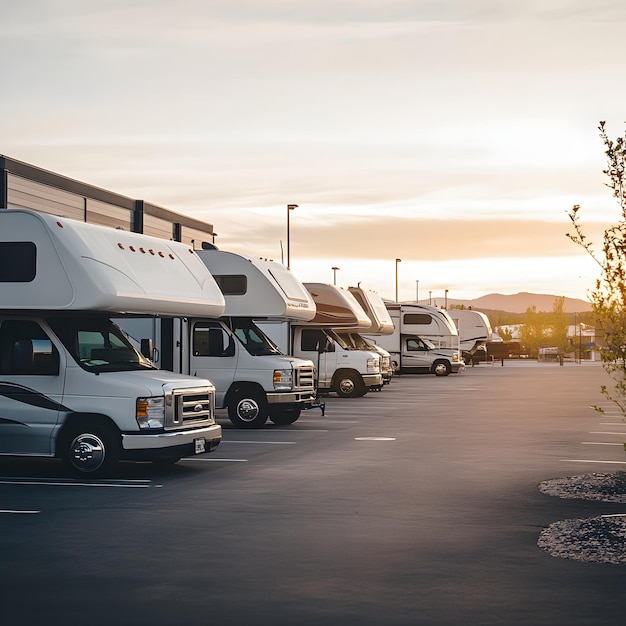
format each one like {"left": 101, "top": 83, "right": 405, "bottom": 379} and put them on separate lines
{"left": 125, "top": 249, "right": 316, "bottom": 428}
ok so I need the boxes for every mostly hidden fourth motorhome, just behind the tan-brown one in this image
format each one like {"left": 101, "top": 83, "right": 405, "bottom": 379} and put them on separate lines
{"left": 336, "top": 285, "right": 394, "bottom": 385}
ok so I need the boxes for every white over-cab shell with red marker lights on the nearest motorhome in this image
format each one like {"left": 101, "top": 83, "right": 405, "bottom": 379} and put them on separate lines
{"left": 0, "top": 209, "right": 225, "bottom": 316}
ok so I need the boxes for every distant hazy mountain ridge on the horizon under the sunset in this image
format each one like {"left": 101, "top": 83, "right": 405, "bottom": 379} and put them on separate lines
{"left": 420, "top": 292, "right": 591, "bottom": 313}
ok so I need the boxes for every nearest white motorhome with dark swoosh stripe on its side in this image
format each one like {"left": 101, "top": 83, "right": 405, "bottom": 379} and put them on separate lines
{"left": 0, "top": 209, "right": 224, "bottom": 476}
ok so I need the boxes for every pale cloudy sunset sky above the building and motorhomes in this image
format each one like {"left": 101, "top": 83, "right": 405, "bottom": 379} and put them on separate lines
{"left": 0, "top": 0, "right": 626, "bottom": 300}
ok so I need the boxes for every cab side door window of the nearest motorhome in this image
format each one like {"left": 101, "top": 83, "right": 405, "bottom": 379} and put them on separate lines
{"left": 0, "top": 320, "right": 59, "bottom": 376}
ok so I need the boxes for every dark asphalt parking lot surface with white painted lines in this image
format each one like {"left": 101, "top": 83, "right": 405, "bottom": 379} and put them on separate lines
{"left": 0, "top": 362, "right": 626, "bottom": 626}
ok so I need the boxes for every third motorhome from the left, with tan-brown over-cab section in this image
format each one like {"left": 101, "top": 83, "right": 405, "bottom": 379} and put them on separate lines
{"left": 259, "top": 283, "right": 383, "bottom": 398}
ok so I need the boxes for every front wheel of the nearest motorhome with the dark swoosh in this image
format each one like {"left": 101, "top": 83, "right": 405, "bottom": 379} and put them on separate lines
{"left": 62, "top": 420, "right": 121, "bottom": 477}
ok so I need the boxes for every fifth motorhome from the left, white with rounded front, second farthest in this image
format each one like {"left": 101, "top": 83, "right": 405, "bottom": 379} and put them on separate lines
{"left": 366, "top": 302, "right": 465, "bottom": 376}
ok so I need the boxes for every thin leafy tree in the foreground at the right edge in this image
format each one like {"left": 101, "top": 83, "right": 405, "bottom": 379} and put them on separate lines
{"left": 567, "top": 122, "right": 626, "bottom": 417}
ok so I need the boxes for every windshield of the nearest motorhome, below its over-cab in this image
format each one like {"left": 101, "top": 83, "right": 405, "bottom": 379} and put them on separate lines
{"left": 47, "top": 317, "right": 156, "bottom": 372}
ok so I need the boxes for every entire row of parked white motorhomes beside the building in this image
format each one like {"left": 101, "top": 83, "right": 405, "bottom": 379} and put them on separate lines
{"left": 0, "top": 210, "right": 491, "bottom": 476}
